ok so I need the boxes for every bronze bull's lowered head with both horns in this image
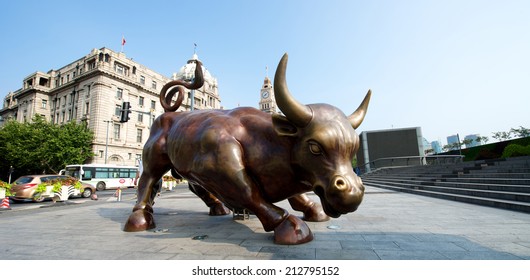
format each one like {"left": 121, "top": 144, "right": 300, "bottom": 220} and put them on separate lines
{"left": 273, "top": 54, "right": 371, "bottom": 218}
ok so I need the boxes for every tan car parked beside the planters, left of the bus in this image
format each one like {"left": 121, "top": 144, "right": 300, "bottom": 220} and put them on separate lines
{"left": 11, "top": 174, "right": 96, "bottom": 202}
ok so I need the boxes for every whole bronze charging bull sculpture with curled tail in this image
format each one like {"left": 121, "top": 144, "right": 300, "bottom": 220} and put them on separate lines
{"left": 124, "top": 54, "right": 371, "bottom": 244}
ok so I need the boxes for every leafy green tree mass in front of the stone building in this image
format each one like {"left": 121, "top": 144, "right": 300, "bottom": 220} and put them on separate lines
{"left": 0, "top": 115, "right": 94, "bottom": 177}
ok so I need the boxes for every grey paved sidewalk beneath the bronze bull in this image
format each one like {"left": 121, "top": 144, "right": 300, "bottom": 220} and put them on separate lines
{"left": 0, "top": 186, "right": 530, "bottom": 260}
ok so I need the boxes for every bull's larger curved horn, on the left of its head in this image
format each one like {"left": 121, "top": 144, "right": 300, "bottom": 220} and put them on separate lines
{"left": 274, "top": 53, "right": 313, "bottom": 127}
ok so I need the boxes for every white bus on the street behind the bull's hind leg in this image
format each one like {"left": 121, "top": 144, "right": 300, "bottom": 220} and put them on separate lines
{"left": 61, "top": 164, "right": 138, "bottom": 191}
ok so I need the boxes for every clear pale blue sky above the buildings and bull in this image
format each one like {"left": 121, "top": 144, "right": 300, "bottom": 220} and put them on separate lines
{"left": 0, "top": 0, "right": 530, "bottom": 144}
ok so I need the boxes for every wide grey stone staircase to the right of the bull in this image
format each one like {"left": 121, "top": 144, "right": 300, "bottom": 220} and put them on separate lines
{"left": 361, "top": 157, "right": 530, "bottom": 213}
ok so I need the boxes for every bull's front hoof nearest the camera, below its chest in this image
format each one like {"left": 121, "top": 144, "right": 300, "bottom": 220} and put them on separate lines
{"left": 274, "top": 214, "right": 313, "bottom": 245}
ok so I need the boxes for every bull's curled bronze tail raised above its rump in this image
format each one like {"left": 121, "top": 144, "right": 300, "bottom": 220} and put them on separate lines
{"left": 160, "top": 60, "right": 204, "bottom": 112}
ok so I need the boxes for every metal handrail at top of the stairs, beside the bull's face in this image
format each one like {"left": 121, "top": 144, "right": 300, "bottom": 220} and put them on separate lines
{"left": 355, "top": 155, "right": 464, "bottom": 174}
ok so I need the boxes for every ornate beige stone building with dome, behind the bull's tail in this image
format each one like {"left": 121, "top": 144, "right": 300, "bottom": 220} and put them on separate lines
{"left": 0, "top": 48, "right": 221, "bottom": 165}
